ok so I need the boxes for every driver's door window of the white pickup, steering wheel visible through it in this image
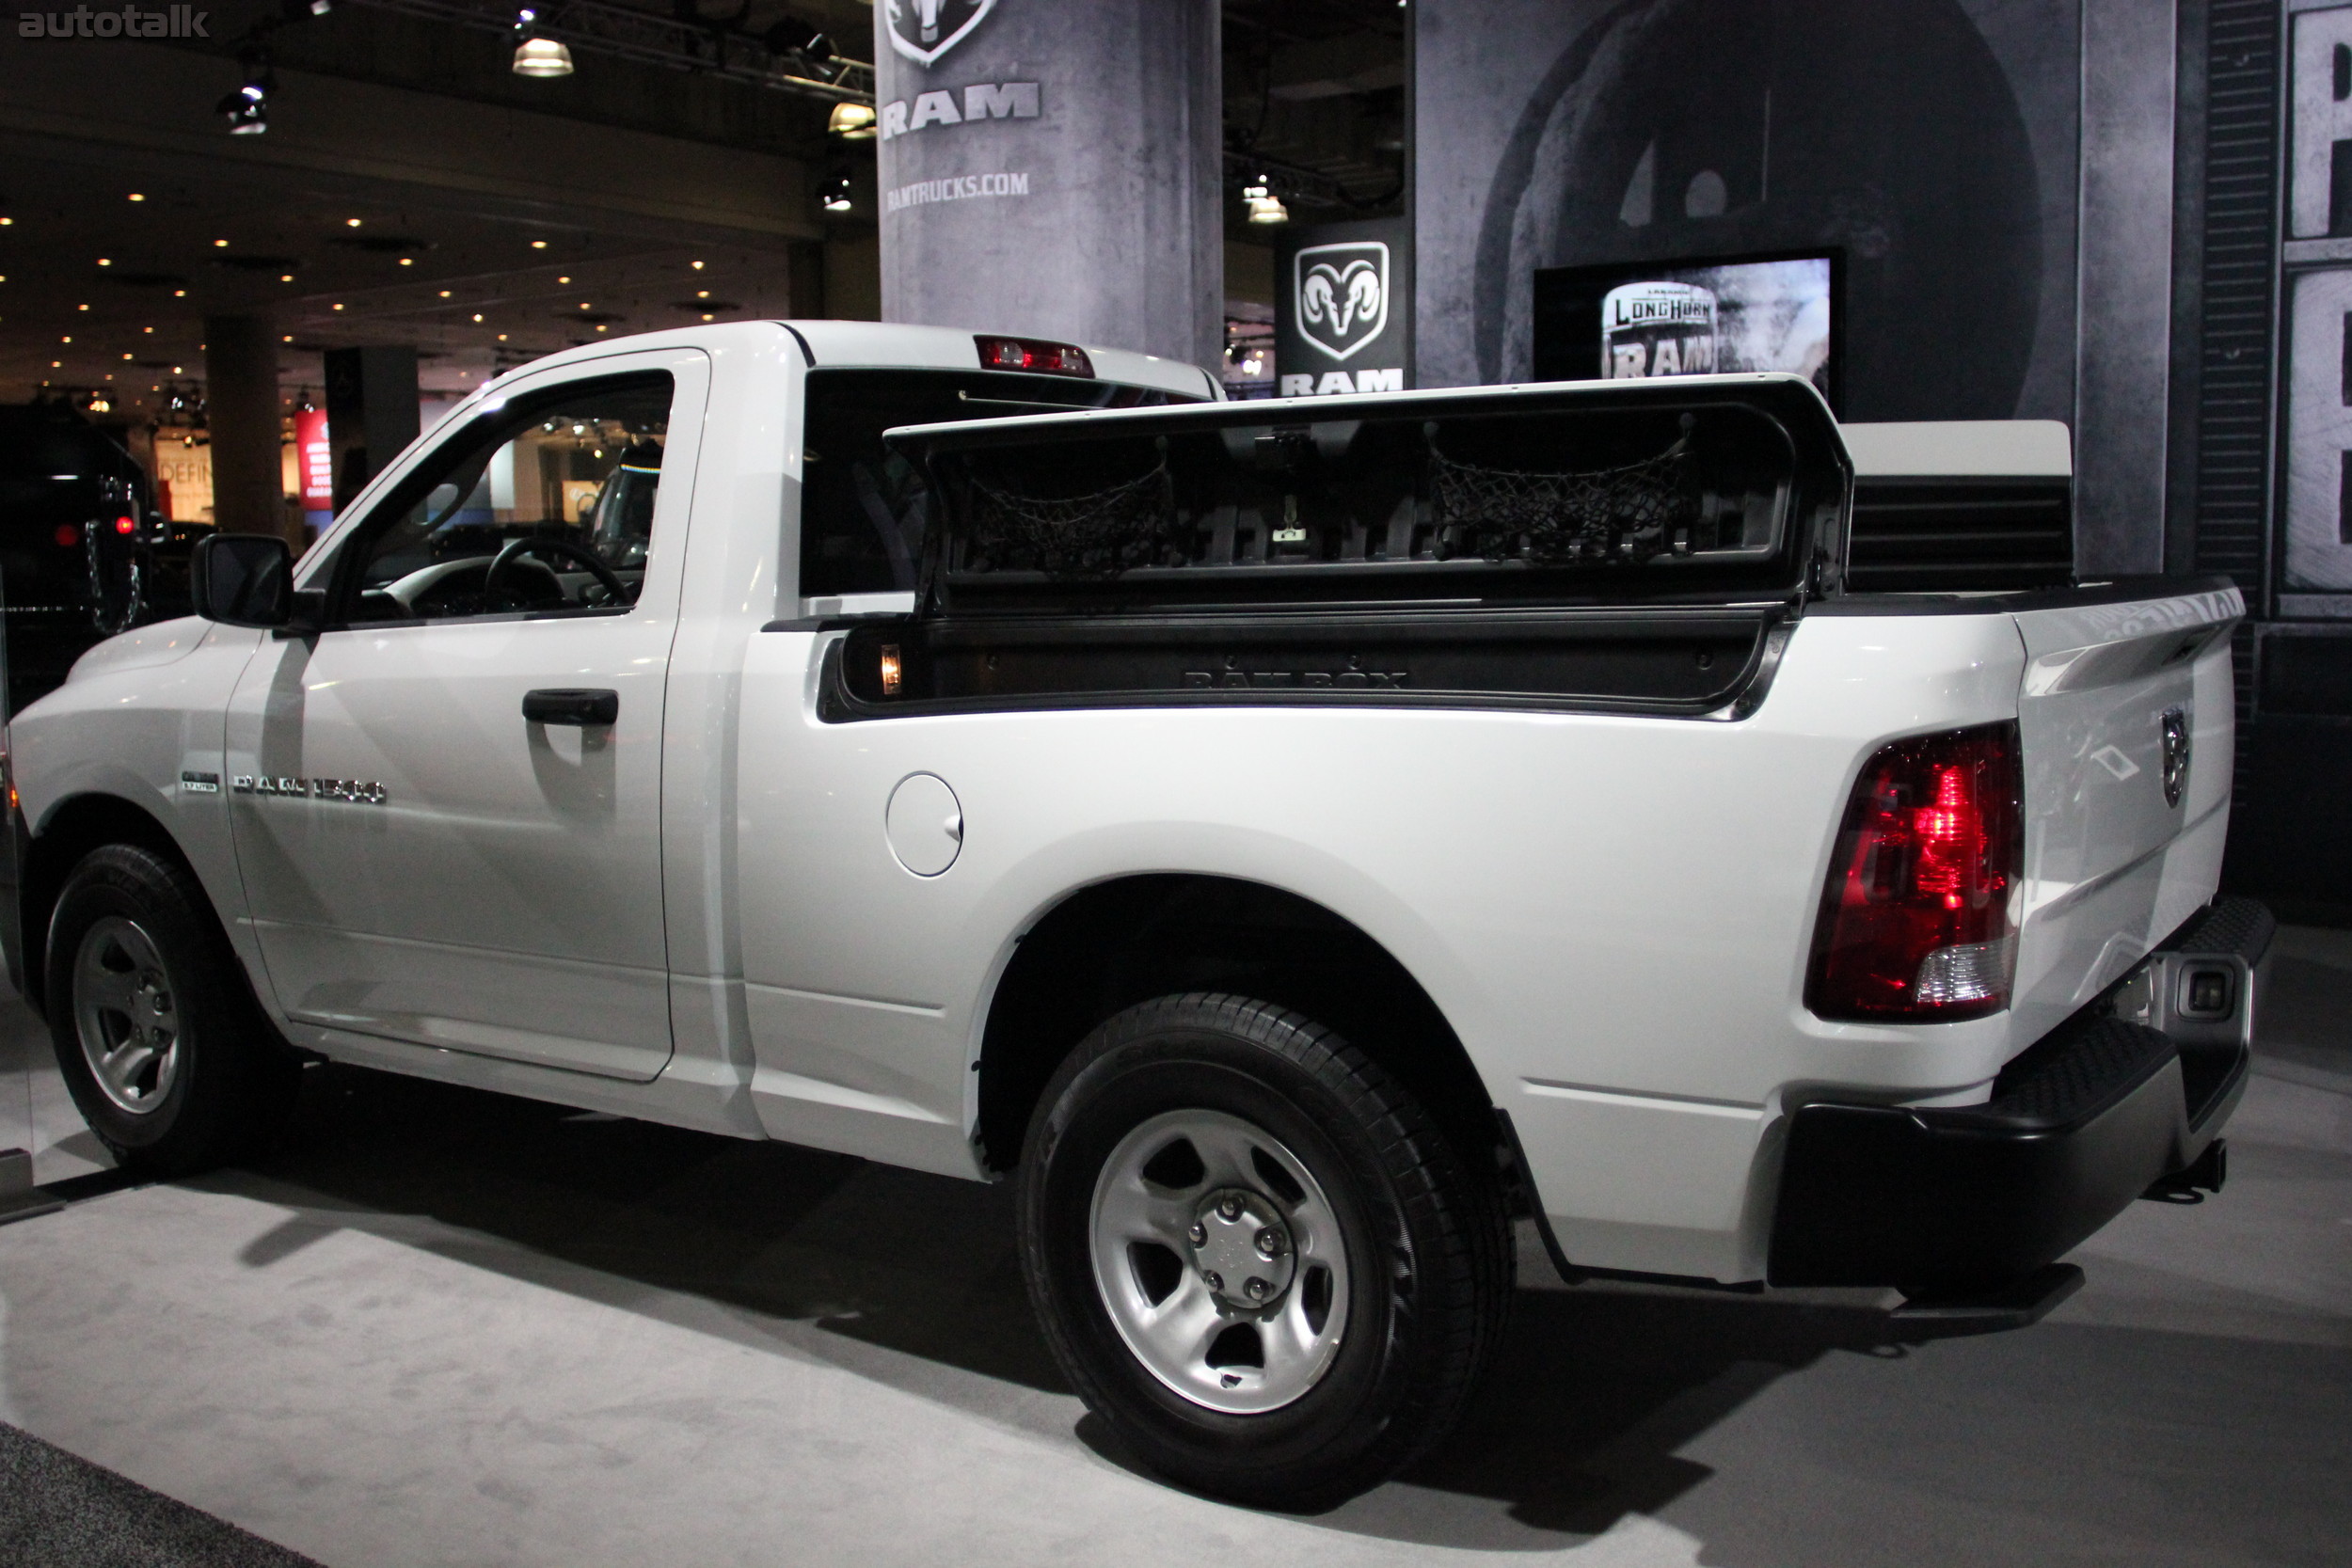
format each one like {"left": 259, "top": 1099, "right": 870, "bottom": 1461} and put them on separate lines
{"left": 339, "top": 372, "right": 673, "bottom": 621}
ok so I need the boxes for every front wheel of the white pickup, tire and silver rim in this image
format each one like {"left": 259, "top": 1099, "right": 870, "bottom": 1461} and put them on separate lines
{"left": 47, "top": 844, "right": 301, "bottom": 1176}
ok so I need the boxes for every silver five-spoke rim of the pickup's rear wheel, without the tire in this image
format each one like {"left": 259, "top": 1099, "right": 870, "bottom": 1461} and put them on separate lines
{"left": 1091, "top": 1110, "right": 1348, "bottom": 1416}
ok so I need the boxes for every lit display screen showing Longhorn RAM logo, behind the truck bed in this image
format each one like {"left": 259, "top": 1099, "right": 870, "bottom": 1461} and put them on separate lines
{"left": 1534, "top": 251, "right": 1842, "bottom": 409}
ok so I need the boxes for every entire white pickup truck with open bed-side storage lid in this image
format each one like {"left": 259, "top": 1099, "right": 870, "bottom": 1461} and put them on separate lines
{"left": 0, "top": 322, "right": 2272, "bottom": 1505}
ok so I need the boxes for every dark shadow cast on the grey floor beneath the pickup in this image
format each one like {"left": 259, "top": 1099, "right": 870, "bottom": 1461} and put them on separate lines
{"left": 221, "top": 1068, "right": 1985, "bottom": 1547}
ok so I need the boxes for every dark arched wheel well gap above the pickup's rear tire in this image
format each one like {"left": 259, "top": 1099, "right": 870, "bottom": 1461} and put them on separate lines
{"left": 978, "top": 875, "right": 1496, "bottom": 1171}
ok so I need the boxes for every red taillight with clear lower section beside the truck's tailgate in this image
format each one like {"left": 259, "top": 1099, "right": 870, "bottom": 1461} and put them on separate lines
{"left": 1804, "top": 724, "right": 2026, "bottom": 1022}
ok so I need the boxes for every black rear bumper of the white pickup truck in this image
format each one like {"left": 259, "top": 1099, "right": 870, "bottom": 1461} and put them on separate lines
{"left": 1767, "top": 898, "right": 2275, "bottom": 1291}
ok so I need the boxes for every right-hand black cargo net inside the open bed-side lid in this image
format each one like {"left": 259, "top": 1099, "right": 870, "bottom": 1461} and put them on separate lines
{"left": 1430, "top": 437, "right": 1701, "bottom": 566}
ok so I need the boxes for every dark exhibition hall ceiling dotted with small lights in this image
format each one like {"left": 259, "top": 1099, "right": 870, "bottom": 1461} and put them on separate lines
{"left": 0, "top": 0, "right": 1406, "bottom": 419}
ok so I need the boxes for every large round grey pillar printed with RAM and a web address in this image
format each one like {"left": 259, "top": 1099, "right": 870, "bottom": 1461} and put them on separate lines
{"left": 875, "top": 0, "right": 1226, "bottom": 367}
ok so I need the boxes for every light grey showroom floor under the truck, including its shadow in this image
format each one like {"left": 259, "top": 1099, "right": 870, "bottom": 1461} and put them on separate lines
{"left": 0, "top": 931, "right": 2352, "bottom": 1568}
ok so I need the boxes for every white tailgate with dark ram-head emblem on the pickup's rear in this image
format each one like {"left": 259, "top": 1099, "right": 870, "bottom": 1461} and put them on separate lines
{"left": 2016, "top": 588, "right": 2247, "bottom": 1039}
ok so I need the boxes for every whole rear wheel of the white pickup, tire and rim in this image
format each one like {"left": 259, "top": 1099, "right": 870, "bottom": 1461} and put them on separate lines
{"left": 1021, "top": 994, "right": 1510, "bottom": 1510}
